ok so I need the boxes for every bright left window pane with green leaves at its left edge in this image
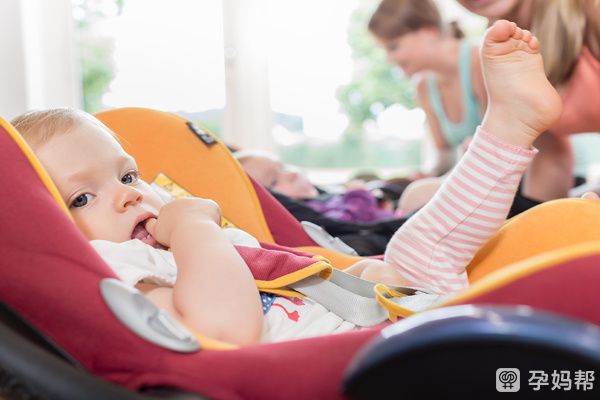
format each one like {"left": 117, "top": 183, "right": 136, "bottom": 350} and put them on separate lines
{"left": 74, "top": 0, "right": 225, "bottom": 133}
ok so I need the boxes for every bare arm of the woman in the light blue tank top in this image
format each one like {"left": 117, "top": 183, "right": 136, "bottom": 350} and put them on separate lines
{"left": 417, "top": 79, "right": 456, "bottom": 176}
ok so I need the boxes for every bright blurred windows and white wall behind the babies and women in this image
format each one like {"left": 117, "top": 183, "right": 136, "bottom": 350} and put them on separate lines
{"left": 0, "top": 0, "right": 596, "bottom": 184}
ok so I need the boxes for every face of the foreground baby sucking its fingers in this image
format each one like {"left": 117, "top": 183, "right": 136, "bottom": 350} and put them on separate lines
{"left": 36, "top": 121, "right": 163, "bottom": 247}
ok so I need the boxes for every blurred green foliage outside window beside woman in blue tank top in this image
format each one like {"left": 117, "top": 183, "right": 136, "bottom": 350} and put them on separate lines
{"left": 280, "top": 1, "right": 421, "bottom": 171}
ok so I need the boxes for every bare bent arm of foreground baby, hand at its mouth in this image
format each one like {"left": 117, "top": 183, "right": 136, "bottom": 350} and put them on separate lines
{"left": 138, "top": 198, "right": 263, "bottom": 345}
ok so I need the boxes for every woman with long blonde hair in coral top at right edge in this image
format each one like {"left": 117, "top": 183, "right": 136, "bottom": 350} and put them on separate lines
{"left": 458, "top": 0, "right": 600, "bottom": 201}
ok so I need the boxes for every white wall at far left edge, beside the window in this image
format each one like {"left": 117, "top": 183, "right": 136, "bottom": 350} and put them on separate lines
{"left": 0, "top": 0, "right": 82, "bottom": 119}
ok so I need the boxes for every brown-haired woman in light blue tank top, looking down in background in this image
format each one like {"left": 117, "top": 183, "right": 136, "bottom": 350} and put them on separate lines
{"left": 369, "top": 0, "right": 486, "bottom": 176}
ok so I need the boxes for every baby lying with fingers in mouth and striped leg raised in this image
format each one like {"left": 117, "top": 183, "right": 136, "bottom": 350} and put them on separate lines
{"left": 13, "top": 21, "right": 561, "bottom": 345}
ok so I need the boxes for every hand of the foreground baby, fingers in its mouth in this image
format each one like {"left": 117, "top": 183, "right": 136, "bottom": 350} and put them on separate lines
{"left": 146, "top": 197, "right": 221, "bottom": 247}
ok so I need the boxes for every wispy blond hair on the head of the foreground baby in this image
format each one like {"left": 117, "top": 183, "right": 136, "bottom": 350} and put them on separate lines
{"left": 11, "top": 108, "right": 114, "bottom": 150}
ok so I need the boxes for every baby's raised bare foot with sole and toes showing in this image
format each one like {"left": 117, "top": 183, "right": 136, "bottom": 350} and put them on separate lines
{"left": 481, "top": 20, "right": 562, "bottom": 148}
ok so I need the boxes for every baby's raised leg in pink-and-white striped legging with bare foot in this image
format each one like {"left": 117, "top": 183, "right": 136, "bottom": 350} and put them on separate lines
{"left": 385, "top": 21, "right": 561, "bottom": 293}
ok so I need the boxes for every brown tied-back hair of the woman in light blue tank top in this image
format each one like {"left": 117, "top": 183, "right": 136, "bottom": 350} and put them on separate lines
{"left": 369, "top": 0, "right": 464, "bottom": 40}
